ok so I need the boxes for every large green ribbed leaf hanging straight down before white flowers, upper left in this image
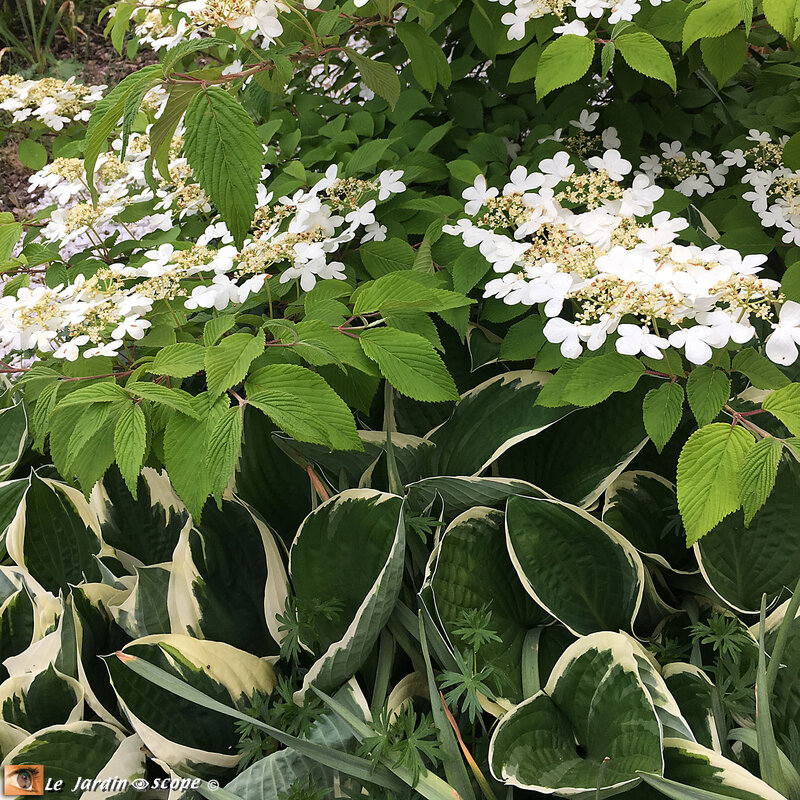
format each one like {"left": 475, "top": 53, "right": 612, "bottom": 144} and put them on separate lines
{"left": 184, "top": 86, "right": 262, "bottom": 244}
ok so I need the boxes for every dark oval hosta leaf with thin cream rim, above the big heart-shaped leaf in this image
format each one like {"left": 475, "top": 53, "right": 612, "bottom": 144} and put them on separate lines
{"left": 506, "top": 497, "right": 644, "bottom": 635}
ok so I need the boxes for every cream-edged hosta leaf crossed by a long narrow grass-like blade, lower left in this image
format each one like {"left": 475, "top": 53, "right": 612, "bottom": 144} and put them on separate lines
{"left": 104, "top": 634, "right": 275, "bottom": 777}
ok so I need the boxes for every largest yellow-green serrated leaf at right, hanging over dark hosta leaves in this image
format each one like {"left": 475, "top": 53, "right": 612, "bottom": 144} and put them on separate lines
{"left": 677, "top": 422, "right": 755, "bottom": 545}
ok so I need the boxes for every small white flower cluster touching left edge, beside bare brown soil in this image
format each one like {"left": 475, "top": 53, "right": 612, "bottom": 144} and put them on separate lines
{"left": 0, "top": 75, "right": 107, "bottom": 131}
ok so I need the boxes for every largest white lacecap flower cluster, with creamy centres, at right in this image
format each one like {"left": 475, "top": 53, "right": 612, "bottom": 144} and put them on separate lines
{"left": 445, "top": 149, "right": 800, "bottom": 364}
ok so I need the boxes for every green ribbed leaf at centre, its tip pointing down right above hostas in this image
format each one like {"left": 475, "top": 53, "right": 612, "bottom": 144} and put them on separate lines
{"left": 359, "top": 328, "right": 458, "bottom": 403}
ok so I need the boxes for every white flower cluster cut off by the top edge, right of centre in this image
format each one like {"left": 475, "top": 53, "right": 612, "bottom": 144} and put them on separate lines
{"left": 492, "top": 0, "right": 668, "bottom": 40}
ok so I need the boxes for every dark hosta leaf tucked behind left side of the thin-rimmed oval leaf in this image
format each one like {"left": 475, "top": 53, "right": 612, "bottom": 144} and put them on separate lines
{"left": 423, "top": 506, "right": 547, "bottom": 703}
